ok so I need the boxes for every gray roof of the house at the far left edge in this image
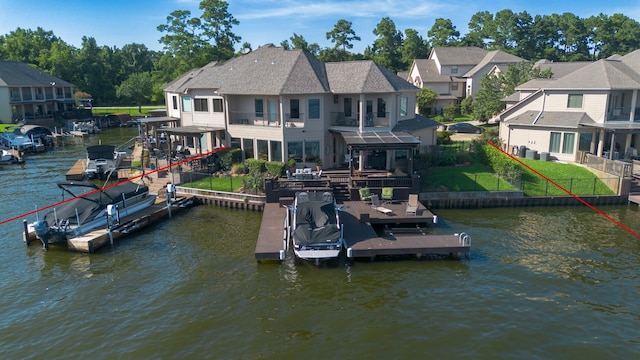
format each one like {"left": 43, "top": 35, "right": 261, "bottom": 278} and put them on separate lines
{"left": 0, "top": 60, "right": 73, "bottom": 87}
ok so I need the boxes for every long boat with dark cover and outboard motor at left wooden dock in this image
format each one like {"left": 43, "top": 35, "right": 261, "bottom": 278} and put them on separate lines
{"left": 28, "top": 182, "right": 156, "bottom": 248}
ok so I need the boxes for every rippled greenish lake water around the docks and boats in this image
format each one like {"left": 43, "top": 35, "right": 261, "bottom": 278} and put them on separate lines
{"left": 0, "top": 129, "right": 640, "bottom": 359}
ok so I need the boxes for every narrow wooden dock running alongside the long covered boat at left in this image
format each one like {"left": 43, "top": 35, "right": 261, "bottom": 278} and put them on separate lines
{"left": 23, "top": 197, "right": 196, "bottom": 253}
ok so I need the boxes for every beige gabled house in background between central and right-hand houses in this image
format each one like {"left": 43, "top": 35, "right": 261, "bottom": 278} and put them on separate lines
{"left": 406, "top": 46, "right": 523, "bottom": 114}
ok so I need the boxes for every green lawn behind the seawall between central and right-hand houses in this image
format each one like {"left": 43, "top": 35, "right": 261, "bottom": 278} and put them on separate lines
{"left": 423, "top": 155, "right": 615, "bottom": 196}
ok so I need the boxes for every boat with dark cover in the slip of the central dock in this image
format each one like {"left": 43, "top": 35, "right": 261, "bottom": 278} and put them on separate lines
{"left": 285, "top": 191, "right": 345, "bottom": 263}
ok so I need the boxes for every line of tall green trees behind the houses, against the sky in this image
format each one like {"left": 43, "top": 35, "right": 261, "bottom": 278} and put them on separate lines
{"left": 0, "top": 0, "right": 640, "bottom": 106}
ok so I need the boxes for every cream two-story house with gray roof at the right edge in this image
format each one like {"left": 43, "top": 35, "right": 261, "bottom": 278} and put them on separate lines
{"left": 495, "top": 50, "right": 640, "bottom": 162}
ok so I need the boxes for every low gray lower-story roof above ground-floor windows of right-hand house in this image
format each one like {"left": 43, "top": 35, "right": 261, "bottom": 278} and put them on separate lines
{"left": 506, "top": 111, "right": 595, "bottom": 128}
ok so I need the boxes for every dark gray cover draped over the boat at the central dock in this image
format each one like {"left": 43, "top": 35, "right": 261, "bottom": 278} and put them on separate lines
{"left": 293, "top": 192, "right": 341, "bottom": 246}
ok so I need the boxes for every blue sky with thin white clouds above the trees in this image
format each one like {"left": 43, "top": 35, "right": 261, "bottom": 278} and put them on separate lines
{"left": 0, "top": 0, "right": 640, "bottom": 53}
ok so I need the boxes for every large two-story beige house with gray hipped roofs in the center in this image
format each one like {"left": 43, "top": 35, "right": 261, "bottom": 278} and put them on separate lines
{"left": 164, "top": 45, "right": 437, "bottom": 174}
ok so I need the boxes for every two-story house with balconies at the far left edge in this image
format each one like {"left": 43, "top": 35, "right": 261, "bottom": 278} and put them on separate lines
{"left": 0, "top": 60, "right": 75, "bottom": 123}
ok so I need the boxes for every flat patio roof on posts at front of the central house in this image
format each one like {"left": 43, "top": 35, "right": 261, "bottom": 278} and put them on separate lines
{"left": 332, "top": 130, "right": 420, "bottom": 149}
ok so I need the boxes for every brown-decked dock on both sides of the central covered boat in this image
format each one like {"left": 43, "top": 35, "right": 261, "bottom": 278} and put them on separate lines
{"left": 255, "top": 201, "right": 471, "bottom": 262}
